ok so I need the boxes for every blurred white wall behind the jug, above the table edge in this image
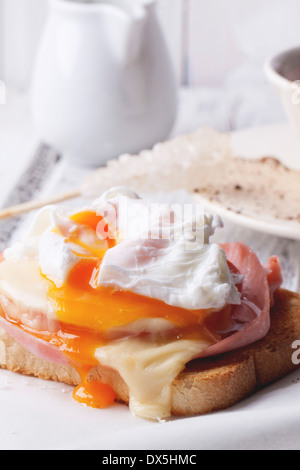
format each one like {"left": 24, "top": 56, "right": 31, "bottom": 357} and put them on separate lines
{"left": 0, "top": 0, "right": 300, "bottom": 89}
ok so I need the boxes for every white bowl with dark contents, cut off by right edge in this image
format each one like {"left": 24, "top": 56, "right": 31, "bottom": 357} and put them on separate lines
{"left": 265, "top": 47, "right": 300, "bottom": 137}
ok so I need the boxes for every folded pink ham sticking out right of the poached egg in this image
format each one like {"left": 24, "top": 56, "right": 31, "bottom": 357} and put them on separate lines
{"left": 197, "top": 243, "right": 282, "bottom": 357}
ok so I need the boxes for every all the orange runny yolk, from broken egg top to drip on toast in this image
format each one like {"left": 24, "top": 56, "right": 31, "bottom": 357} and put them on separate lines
{"left": 1, "top": 211, "right": 223, "bottom": 408}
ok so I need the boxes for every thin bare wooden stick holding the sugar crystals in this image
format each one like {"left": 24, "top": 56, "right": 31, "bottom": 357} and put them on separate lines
{"left": 0, "top": 189, "right": 81, "bottom": 220}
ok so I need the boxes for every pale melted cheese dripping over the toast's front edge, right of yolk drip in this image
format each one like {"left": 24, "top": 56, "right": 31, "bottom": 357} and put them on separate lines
{"left": 95, "top": 338, "right": 209, "bottom": 420}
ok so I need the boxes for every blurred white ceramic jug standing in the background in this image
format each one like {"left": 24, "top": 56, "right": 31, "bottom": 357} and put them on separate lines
{"left": 32, "top": 0, "right": 177, "bottom": 165}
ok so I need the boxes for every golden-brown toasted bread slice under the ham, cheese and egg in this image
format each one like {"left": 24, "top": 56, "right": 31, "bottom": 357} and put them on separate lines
{"left": 0, "top": 289, "right": 300, "bottom": 416}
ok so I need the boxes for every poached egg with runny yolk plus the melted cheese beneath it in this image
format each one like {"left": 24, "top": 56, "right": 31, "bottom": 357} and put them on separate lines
{"left": 0, "top": 188, "right": 242, "bottom": 419}
